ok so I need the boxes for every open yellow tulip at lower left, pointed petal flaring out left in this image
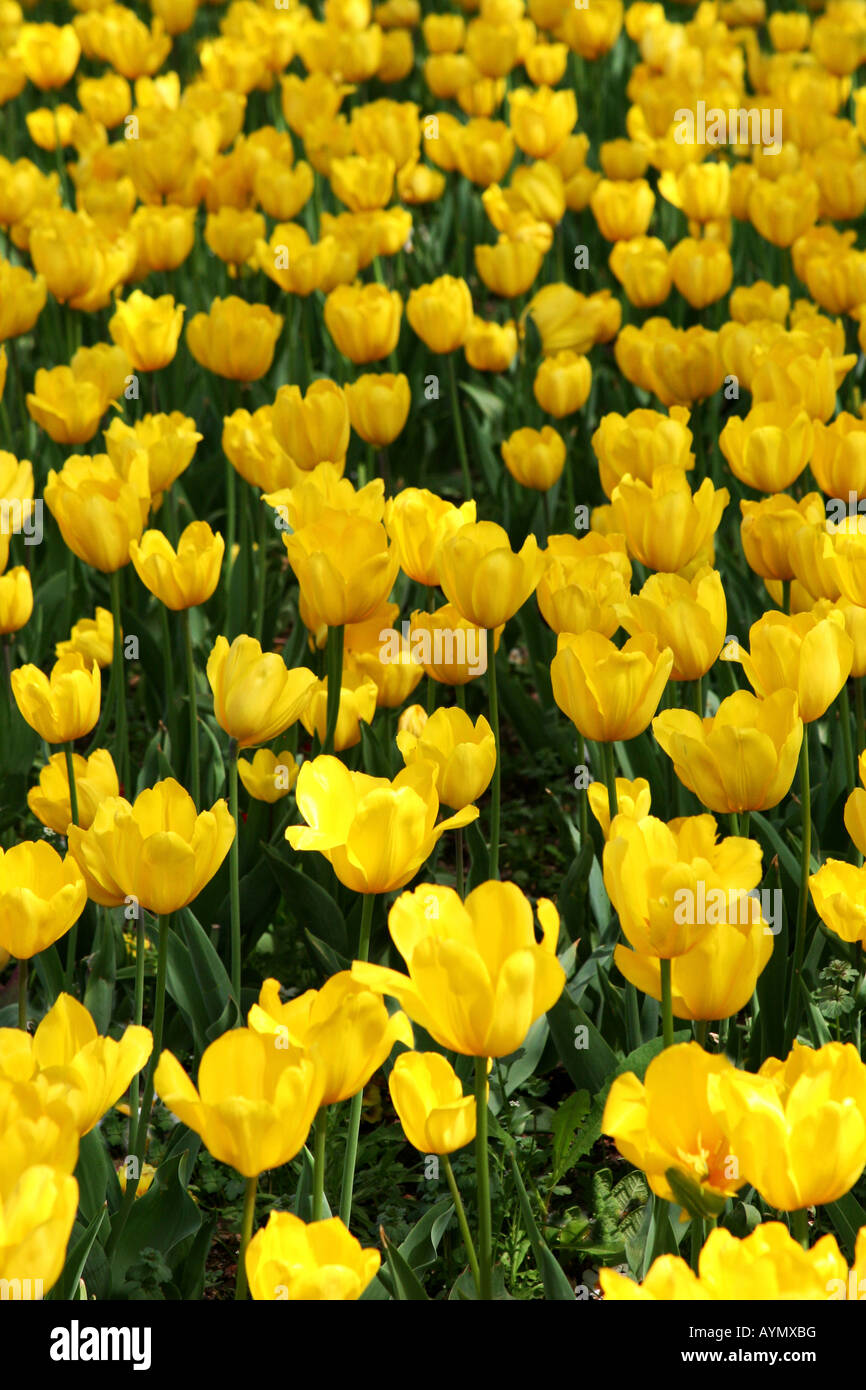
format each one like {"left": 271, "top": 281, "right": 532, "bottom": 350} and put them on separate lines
{"left": 154, "top": 1029, "right": 322, "bottom": 1177}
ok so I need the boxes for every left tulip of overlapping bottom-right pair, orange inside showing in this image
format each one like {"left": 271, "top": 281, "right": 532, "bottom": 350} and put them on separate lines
{"left": 602, "top": 1043, "right": 745, "bottom": 1215}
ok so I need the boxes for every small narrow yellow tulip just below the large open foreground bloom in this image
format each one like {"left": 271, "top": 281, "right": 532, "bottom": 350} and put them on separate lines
{"left": 388, "top": 1052, "right": 475, "bottom": 1154}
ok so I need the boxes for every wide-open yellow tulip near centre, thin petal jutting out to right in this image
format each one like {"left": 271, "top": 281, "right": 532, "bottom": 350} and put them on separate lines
{"left": 286, "top": 756, "right": 478, "bottom": 894}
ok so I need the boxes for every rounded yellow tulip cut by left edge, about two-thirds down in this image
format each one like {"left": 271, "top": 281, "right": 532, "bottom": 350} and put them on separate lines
{"left": 0, "top": 840, "right": 88, "bottom": 961}
